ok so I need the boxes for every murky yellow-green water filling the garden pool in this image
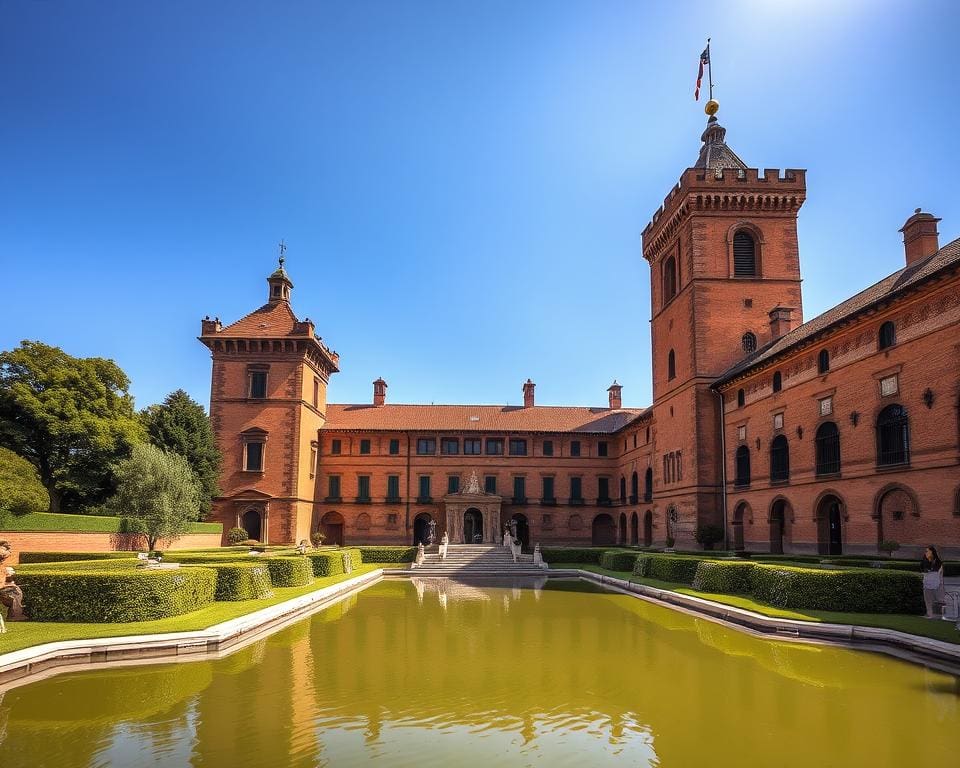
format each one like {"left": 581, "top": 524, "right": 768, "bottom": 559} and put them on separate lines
{"left": 0, "top": 580, "right": 960, "bottom": 768}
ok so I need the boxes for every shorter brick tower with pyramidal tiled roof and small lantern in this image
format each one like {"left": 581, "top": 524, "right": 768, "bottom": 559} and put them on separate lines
{"left": 200, "top": 255, "right": 339, "bottom": 544}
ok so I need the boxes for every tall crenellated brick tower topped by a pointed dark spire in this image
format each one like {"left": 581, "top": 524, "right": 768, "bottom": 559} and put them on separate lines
{"left": 643, "top": 109, "right": 806, "bottom": 546}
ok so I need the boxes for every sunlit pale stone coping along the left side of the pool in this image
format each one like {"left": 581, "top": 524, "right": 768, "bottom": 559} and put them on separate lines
{"left": 0, "top": 568, "right": 383, "bottom": 693}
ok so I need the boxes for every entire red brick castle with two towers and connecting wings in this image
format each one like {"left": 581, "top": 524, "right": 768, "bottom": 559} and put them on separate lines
{"left": 200, "top": 111, "right": 960, "bottom": 556}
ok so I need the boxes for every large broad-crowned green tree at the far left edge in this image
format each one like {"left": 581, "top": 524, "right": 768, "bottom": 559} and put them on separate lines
{"left": 0, "top": 341, "right": 144, "bottom": 512}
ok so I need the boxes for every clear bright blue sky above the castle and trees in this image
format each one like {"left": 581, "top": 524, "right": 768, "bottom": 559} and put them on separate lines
{"left": 0, "top": 0, "right": 960, "bottom": 414}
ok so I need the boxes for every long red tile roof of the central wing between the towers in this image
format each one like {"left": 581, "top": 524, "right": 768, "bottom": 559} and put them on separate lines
{"left": 324, "top": 404, "right": 649, "bottom": 434}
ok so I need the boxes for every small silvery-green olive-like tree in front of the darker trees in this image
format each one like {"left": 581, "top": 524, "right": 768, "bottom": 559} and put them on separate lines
{"left": 107, "top": 443, "right": 200, "bottom": 550}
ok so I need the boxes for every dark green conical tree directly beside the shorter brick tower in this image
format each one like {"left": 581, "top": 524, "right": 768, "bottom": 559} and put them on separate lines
{"left": 141, "top": 389, "right": 222, "bottom": 516}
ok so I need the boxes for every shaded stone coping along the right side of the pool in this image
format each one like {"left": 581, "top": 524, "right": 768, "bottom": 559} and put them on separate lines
{"left": 560, "top": 568, "right": 960, "bottom": 674}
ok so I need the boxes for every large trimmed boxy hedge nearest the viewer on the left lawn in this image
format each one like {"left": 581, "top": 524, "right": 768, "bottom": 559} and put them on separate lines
{"left": 17, "top": 568, "right": 217, "bottom": 624}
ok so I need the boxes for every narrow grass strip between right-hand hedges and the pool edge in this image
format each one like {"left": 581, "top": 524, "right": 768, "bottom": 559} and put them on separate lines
{"left": 550, "top": 563, "right": 960, "bottom": 645}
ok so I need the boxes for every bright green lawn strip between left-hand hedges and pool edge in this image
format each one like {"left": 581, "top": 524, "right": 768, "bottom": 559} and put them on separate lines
{"left": 0, "top": 563, "right": 394, "bottom": 654}
